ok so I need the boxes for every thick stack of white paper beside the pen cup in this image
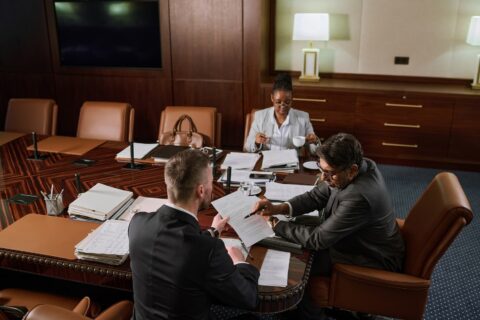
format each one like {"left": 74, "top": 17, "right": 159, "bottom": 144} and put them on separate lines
{"left": 68, "top": 183, "right": 133, "bottom": 221}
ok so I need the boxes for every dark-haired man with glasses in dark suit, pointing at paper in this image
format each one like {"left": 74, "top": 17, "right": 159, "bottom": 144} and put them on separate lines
{"left": 254, "top": 133, "right": 405, "bottom": 318}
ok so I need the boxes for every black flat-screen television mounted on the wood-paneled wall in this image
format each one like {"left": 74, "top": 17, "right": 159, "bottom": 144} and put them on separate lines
{"left": 53, "top": 0, "right": 162, "bottom": 68}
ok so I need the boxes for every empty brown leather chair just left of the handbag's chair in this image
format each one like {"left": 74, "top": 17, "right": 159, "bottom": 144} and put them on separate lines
{"left": 77, "top": 101, "right": 135, "bottom": 142}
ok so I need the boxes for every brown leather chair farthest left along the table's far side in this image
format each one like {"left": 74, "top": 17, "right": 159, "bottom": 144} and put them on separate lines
{"left": 5, "top": 99, "right": 58, "bottom": 135}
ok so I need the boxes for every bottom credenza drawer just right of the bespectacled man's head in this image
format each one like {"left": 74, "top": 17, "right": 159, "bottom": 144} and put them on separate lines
{"left": 357, "top": 133, "right": 448, "bottom": 158}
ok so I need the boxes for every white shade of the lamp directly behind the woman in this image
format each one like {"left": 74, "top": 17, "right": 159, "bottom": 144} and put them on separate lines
{"left": 293, "top": 13, "right": 330, "bottom": 41}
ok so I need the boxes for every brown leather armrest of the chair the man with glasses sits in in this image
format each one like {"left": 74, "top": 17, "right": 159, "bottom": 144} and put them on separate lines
{"left": 334, "top": 263, "right": 430, "bottom": 290}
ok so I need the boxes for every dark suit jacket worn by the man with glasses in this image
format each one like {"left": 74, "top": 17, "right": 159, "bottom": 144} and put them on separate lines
{"left": 274, "top": 159, "right": 405, "bottom": 271}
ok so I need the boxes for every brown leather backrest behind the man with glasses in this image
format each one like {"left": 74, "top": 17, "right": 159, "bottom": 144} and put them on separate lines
{"left": 402, "top": 172, "right": 473, "bottom": 279}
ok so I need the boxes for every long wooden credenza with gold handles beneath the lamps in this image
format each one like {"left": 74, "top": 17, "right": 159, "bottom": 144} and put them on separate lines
{"left": 262, "top": 79, "right": 480, "bottom": 170}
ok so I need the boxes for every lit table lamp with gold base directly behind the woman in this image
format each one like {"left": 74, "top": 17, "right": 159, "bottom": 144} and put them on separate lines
{"left": 292, "top": 13, "right": 329, "bottom": 81}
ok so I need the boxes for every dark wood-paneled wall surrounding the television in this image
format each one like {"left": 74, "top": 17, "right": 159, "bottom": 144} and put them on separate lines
{"left": 0, "top": 0, "right": 270, "bottom": 148}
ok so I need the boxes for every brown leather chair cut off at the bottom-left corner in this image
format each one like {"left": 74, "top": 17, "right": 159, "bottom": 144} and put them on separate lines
{"left": 0, "top": 288, "right": 99, "bottom": 319}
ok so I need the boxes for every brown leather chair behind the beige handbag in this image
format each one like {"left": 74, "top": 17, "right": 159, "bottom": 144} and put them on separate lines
{"left": 158, "top": 106, "right": 222, "bottom": 147}
